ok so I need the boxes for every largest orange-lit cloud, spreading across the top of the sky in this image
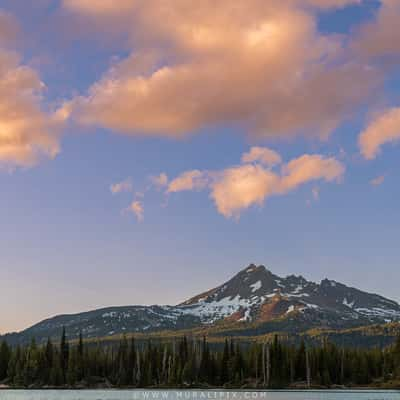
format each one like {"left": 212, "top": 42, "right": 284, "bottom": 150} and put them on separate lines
{"left": 63, "top": 0, "right": 378, "bottom": 138}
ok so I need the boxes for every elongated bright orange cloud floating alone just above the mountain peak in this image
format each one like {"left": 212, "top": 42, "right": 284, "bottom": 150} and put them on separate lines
{"left": 167, "top": 148, "right": 345, "bottom": 218}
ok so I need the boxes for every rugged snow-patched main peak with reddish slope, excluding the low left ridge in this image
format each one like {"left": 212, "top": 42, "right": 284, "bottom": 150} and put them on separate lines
{"left": 180, "top": 265, "right": 400, "bottom": 323}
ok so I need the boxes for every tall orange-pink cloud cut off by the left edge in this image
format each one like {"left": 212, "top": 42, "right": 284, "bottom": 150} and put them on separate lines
{"left": 0, "top": 12, "right": 60, "bottom": 168}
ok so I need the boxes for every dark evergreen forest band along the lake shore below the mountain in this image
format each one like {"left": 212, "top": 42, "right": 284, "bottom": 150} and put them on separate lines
{"left": 0, "top": 330, "right": 400, "bottom": 388}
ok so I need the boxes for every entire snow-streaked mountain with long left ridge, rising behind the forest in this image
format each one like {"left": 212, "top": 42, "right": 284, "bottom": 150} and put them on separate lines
{"left": 5, "top": 264, "right": 400, "bottom": 343}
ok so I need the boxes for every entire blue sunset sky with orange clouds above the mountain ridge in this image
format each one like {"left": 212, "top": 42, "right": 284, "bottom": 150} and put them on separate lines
{"left": 0, "top": 0, "right": 400, "bottom": 333}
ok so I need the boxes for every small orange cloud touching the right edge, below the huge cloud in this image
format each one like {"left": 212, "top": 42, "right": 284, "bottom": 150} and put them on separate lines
{"left": 358, "top": 108, "right": 400, "bottom": 160}
